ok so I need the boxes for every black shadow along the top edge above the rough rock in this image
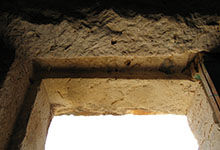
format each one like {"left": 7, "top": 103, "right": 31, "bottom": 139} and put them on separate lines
{"left": 0, "top": 0, "right": 220, "bottom": 25}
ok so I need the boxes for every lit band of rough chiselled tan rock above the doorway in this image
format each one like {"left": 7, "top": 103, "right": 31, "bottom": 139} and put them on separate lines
{"left": 4, "top": 9, "right": 220, "bottom": 58}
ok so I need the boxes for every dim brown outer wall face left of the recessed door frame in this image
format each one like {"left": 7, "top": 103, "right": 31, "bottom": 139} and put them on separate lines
{"left": 0, "top": 59, "right": 32, "bottom": 150}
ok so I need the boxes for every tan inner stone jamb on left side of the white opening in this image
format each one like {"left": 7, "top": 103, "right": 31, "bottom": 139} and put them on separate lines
{"left": 20, "top": 83, "right": 52, "bottom": 150}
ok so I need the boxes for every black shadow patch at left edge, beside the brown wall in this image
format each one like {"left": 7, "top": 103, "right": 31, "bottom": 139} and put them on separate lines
{"left": 0, "top": 35, "right": 15, "bottom": 88}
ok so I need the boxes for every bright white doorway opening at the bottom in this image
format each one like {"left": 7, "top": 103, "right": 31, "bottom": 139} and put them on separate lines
{"left": 45, "top": 115, "right": 198, "bottom": 150}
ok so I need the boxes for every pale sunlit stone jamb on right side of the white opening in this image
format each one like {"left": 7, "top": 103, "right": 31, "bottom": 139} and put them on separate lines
{"left": 187, "top": 84, "right": 220, "bottom": 150}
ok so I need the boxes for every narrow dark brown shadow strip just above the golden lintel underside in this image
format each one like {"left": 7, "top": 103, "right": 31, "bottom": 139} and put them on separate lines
{"left": 38, "top": 69, "right": 191, "bottom": 80}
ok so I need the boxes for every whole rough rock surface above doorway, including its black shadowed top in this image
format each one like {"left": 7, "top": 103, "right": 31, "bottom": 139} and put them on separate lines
{"left": 0, "top": 0, "right": 220, "bottom": 57}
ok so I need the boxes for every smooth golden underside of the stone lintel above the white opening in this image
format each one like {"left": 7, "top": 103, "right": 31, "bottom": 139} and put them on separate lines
{"left": 43, "top": 78, "right": 197, "bottom": 115}
